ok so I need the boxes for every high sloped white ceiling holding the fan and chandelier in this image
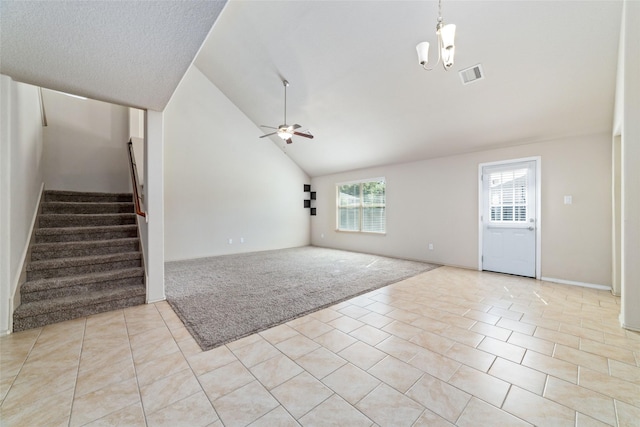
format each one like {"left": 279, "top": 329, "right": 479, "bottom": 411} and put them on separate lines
{"left": 195, "top": 0, "right": 622, "bottom": 176}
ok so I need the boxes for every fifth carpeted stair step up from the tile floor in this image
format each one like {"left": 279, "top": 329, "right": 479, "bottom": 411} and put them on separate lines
{"left": 35, "top": 224, "right": 138, "bottom": 243}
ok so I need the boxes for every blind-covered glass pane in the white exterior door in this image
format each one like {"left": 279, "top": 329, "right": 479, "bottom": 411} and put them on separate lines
{"left": 488, "top": 168, "right": 528, "bottom": 223}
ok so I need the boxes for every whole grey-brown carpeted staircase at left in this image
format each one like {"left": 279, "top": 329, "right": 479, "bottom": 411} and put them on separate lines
{"left": 13, "top": 191, "right": 146, "bottom": 332}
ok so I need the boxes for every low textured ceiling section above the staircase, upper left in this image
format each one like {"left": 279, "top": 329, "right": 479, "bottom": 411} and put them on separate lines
{"left": 0, "top": 0, "right": 225, "bottom": 111}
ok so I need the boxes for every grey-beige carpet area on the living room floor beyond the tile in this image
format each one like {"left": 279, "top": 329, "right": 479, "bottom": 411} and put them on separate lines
{"left": 165, "top": 246, "right": 437, "bottom": 350}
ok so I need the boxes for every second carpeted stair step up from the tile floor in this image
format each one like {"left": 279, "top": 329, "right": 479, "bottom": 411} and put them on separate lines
{"left": 20, "top": 267, "right": 145, "bottom": 304}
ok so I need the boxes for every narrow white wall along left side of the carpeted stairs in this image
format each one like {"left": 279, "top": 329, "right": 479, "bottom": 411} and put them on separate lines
{"left": 0, "top": 75, "right": 43, "bottom": 334}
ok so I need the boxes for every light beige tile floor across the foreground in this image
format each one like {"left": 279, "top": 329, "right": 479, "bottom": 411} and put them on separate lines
{"left": 0, "top": 267, "right": 640, "bottom": 426}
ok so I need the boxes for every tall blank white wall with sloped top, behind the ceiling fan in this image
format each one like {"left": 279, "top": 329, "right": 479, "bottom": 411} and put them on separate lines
{"left": 164, "top": 66, "right": 310, "bottom": 261}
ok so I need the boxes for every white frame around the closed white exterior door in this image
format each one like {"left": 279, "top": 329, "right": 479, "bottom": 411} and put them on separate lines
{"left": 478, "top": 156, "right": 542, "bottom": 280}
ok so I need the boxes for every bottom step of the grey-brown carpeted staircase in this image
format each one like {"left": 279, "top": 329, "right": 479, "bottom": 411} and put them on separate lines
{"left": 13, "top": 285, "right": 146, "bottom": 332}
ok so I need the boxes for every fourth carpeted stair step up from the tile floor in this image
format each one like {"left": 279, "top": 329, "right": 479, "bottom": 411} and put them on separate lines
{"left": 31, "top": 237, "right": 140, "bottom": 262}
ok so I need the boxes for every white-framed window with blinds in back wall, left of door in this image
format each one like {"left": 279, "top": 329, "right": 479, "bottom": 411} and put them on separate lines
{"left": 336, "top": 178, "right": 386, "bottom": 233}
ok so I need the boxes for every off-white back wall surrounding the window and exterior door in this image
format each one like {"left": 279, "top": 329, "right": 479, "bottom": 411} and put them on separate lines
{"left": 311, "top": 134, "right": 611, "bottom": 286}
